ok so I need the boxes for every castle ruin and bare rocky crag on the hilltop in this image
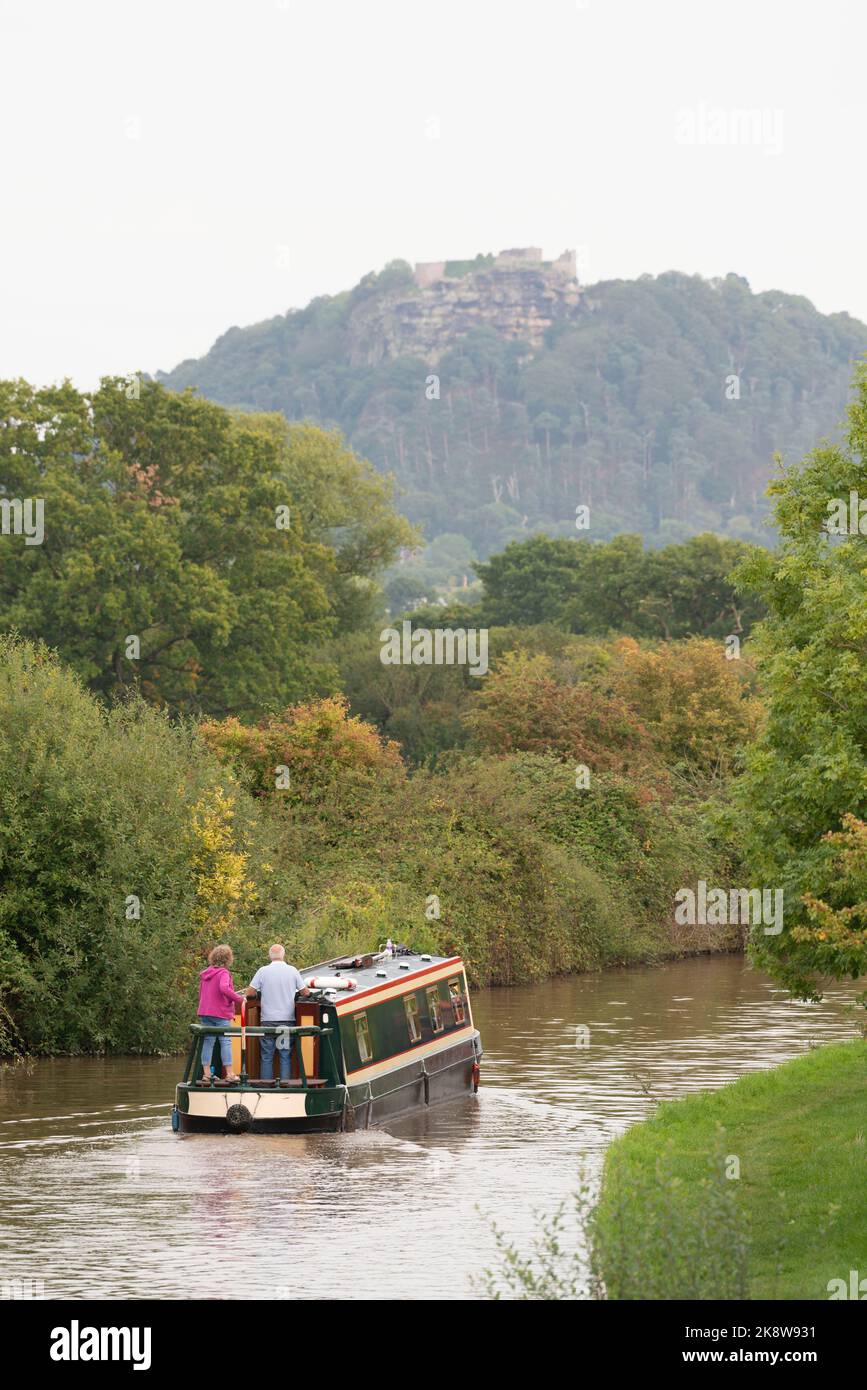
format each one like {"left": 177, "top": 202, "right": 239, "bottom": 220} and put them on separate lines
{"left": 350, "top": 246, "right": 582, "bottom": 366}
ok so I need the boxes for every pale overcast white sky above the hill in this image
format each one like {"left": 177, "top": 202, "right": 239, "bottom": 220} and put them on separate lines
{"left": 0, "top": 0, "right": 867, "bottom": 386}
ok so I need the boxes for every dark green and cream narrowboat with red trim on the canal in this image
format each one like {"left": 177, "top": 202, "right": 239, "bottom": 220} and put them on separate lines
{"left": 172, "top": 947, "right": 482, "bottom": 1134}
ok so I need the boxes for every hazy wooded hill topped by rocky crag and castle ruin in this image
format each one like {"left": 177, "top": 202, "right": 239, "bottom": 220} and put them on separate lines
{"left": 158, "top": 250, "right": 867, "bottom": 571}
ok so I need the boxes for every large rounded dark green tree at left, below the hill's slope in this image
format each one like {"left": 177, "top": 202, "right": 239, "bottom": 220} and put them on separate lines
{"left": 0, "top": 379, "right": 408, "bottom": 717}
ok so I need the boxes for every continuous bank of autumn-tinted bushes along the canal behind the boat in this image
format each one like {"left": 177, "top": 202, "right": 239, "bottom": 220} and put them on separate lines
{"left": 0, "top": 638, "right": 742, "bottom": 1056}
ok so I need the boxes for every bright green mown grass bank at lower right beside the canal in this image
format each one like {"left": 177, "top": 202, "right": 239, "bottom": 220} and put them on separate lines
{"left": 592, "top": 1040, "right": 867, "bottom": 1300}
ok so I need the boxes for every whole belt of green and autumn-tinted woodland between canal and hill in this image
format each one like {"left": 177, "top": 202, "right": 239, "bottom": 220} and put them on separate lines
{"left": 0, "top": 375, "right": 867, "bottom": 1052}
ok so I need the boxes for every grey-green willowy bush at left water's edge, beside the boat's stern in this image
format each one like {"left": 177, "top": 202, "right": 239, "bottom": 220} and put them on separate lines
{"left": 0, "top": 637, "right": 272, "bottom": 1052}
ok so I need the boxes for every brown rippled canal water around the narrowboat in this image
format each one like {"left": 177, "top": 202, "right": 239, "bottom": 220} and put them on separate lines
{"left": 0, "top": 956, "right": 856, "bottom": 1300}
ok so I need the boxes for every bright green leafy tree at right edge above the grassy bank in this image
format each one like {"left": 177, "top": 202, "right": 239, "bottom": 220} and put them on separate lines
{"left": 735, "top": 367, "right": 867, "bottom": 998}
